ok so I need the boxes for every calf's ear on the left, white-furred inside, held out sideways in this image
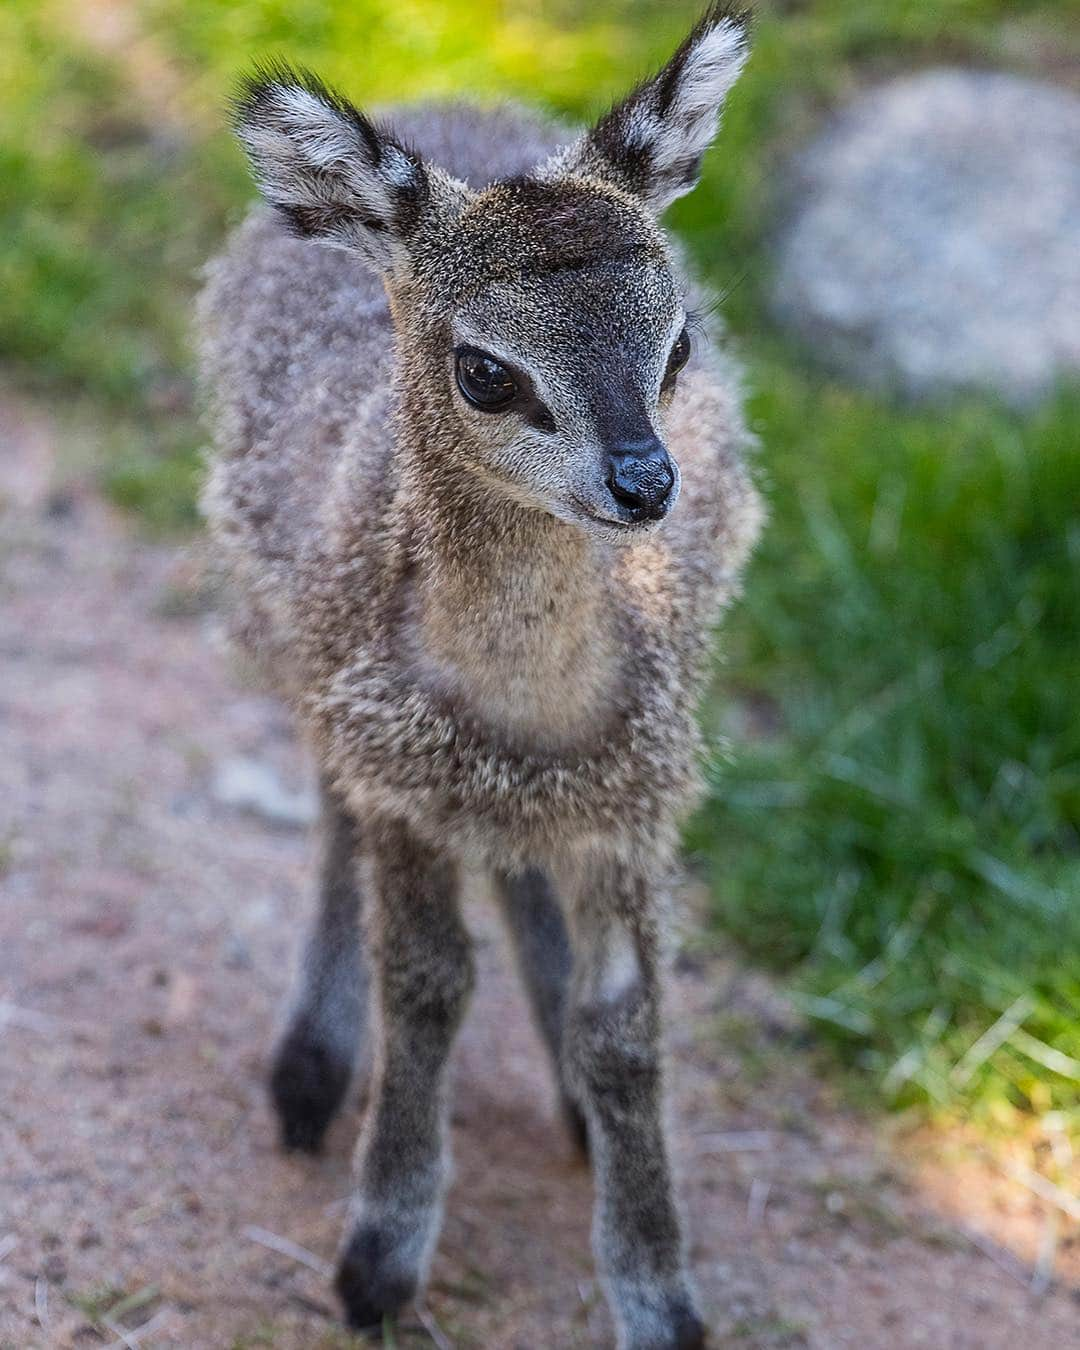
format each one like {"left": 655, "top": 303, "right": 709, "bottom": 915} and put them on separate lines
{"left": 234, "top": 65, "right": 451, "bottom": 271}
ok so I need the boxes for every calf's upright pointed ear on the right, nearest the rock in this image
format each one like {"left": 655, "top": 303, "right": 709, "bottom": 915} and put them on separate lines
{"left": 540, "top": 4, "right": 749, "bottom": 213}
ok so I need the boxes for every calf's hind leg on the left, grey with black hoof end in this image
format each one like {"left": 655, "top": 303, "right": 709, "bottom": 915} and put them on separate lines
{"left": 270, "top": 784, "right": 369, "bottom": 1153}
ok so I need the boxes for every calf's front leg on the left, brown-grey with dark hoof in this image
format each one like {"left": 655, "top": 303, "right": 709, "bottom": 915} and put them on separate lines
{"left": 336, "top": 826, "right": 473, "bottom": 1328}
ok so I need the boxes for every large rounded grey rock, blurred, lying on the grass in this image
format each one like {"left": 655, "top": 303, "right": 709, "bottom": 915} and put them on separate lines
{"left": 774, "top": 70, "right": 1080, "bottom": 405}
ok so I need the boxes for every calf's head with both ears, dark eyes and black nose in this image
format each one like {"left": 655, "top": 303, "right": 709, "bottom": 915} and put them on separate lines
{"left": 236, "top": 5, "right": 747, "bottom": 536}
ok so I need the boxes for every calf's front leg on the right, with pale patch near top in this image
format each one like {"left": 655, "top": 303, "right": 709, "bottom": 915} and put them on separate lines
{"left": 566, "top": 864, "right": 705, "bottom": 1350}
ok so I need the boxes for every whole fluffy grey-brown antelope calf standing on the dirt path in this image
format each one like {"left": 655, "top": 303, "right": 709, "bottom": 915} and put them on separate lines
{"left": 201, "top": 7, "right": 760, "bottom": 1350}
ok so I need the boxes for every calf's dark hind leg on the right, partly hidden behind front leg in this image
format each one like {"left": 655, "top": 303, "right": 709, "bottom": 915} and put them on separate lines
{"left": 495, "top": 867, "right": 589, "bottom": 1153}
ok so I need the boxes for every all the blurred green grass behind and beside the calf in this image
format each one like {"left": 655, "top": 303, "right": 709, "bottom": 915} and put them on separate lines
{"left": 0, "top": 0, "right": 1080, "bottom": 1130}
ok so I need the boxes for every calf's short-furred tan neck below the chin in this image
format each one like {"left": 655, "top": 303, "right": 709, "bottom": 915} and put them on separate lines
{"left": 405, "top": 454, "right": 618, "bottom": 748}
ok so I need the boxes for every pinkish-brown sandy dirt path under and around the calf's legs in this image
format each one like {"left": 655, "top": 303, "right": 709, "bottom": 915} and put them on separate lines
{"left": 0, "top": 398, "right": 1080, "bottom": 1350}
